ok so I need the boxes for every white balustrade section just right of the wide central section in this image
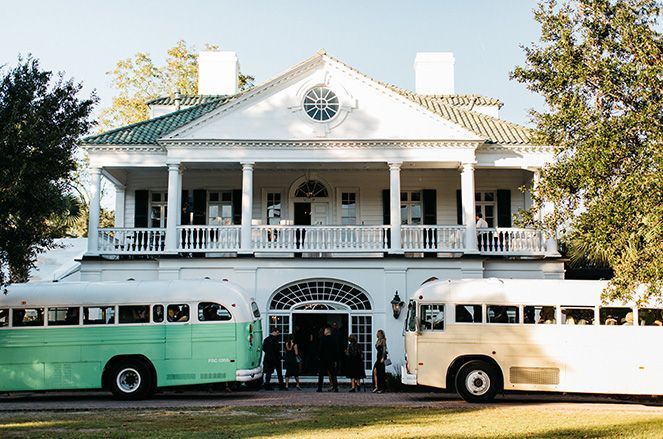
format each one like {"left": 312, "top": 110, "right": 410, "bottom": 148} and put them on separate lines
{"left": 401, "top": 225, "right": 465, "bottom": 252}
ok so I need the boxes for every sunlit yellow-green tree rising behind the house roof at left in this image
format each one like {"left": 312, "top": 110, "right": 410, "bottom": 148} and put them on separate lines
{"left": 99, "top": 40, "right": 255, "bottom": 131}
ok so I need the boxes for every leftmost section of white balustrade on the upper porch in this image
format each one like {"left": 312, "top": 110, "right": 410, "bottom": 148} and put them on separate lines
{"left": 98, "top": 228, "right": 166, "bottom": 255}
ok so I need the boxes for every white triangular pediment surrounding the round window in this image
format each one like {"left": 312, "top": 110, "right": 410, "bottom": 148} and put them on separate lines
{"left": 161, "top": 54, "right": 482, "bottom": 141}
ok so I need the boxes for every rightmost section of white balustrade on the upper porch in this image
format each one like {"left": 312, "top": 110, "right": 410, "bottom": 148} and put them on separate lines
{"left": 477, "top": 228, "right": 546, "bottom": 256}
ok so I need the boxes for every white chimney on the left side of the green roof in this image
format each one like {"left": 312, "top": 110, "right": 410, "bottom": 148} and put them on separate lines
{"left": 198, "top": 51, "right": 239, "bottom": 95}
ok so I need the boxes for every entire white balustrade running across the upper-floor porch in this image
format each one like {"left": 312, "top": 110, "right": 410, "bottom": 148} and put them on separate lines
{"left": 98, "top": 225, "right": 546, "bottom": 257}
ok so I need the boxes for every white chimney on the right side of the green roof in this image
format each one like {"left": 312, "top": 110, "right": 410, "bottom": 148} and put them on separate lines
{"left": 414, "top": 52, "right": 455, "bottom": 95}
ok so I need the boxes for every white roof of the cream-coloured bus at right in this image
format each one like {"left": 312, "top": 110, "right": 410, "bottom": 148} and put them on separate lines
{"left": 412, "top": 278, "right": 660, "bottom": 306}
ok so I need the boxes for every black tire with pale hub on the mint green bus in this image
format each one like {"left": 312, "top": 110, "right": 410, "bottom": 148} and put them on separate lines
{"left": 109, "top": 360, "right": 154, "bottom": 400}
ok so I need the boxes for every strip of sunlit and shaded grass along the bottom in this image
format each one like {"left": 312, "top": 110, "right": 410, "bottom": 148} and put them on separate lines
{"left": 0, "top": 405, "right": 663, "bottom": 439}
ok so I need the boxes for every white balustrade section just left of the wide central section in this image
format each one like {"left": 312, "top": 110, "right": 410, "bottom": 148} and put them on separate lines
{"left": 177, "top": 226, "right": 242, "bottom": 253}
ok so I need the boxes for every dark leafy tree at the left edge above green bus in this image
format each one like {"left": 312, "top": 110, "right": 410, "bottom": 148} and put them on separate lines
{"left": 0, "top": 57, "right": 96, "bottom": 285}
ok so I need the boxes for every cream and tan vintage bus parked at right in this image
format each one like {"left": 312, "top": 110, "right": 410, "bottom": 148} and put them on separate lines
{"left": 401, "top": 279, "right": 663, "bottom": 402}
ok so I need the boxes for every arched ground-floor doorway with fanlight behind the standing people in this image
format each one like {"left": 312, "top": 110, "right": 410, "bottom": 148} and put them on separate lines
{"left": 268, "top": 279, "right": 373, "bottom": 375}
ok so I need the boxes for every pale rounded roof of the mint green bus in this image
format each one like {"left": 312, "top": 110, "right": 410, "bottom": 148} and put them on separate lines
{"left": 0, "top": 279, "right": 252, "bottom": 319}
